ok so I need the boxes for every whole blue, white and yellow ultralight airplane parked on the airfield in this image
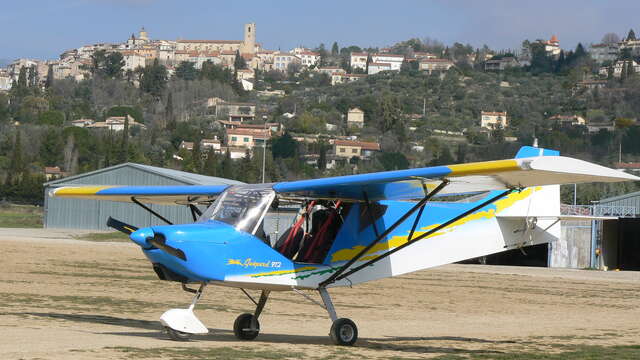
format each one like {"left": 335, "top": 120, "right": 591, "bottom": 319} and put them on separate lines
{"left": 50, "top": 146, "right": 640, "bottom": 345}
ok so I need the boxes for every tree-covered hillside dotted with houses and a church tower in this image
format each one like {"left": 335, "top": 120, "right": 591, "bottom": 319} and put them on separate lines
{"left": 0, "top": 23, "right": 640, "bottom": 202}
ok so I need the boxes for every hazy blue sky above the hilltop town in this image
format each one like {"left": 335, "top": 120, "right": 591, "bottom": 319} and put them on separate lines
{"left": 0, "top": 0, "right": 640, "bottom": 60}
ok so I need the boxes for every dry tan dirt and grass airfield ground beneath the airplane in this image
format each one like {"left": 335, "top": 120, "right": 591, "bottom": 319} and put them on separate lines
{"left": 0, "top": 229, "right": 640, "bottom": 359}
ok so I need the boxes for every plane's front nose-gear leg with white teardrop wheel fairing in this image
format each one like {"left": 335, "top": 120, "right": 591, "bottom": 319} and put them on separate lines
{"left": 160, "top": 282, "right": 209, "bottom": 341}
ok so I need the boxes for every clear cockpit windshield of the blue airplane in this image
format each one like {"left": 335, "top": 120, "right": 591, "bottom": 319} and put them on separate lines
{"left": 198, "top": 185, "right": 275, "bottom": 234}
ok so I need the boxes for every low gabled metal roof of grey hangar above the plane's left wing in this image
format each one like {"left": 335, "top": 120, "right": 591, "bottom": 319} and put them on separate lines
{"left": 44, "top": 163, "right": 243, "bottom": 186}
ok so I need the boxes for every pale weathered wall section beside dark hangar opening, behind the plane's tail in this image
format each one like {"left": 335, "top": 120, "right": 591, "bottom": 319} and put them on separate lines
{"left": 549, "top": 221, "right": 591, "bottom": 269}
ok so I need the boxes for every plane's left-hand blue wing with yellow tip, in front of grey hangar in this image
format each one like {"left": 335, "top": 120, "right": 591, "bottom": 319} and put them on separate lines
{"left": 49, "top": 185, "right": 229, "bottom": 205}
